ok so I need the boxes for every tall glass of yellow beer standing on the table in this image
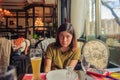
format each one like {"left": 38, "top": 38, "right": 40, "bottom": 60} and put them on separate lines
{"left": 30, "top": 49, "right": 42, "bottom": 80}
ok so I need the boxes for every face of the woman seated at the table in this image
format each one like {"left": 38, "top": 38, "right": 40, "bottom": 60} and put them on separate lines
{"left": 59, "top": 31, "right": 73, "bottom": 47}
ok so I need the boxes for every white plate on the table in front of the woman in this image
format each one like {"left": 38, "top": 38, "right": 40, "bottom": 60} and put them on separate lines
{"left": 46, "top": 69, "right": 78, "bottom": 80}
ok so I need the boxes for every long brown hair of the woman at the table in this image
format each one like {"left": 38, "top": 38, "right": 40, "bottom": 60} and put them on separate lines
{"left": 55, "top": 23, "right": 77, "bottom": 50}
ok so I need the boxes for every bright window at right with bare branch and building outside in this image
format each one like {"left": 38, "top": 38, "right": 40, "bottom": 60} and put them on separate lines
{"left": 86, "top": 0, "right": 120, "bottom": 65}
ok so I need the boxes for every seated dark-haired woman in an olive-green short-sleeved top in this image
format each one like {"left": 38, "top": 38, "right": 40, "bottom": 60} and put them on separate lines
{"left": 44, "top": 23, "right": 80, "bottom": 72}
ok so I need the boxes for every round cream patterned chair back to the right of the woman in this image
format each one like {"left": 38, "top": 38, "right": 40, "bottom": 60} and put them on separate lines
{"left": 81, "top": 39, "right": 109, "bottom": 69}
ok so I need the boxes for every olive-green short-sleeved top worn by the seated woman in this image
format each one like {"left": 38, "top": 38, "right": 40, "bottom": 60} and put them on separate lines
{"left": 45, "top": 44, "right": 80, "bottom": 70}
